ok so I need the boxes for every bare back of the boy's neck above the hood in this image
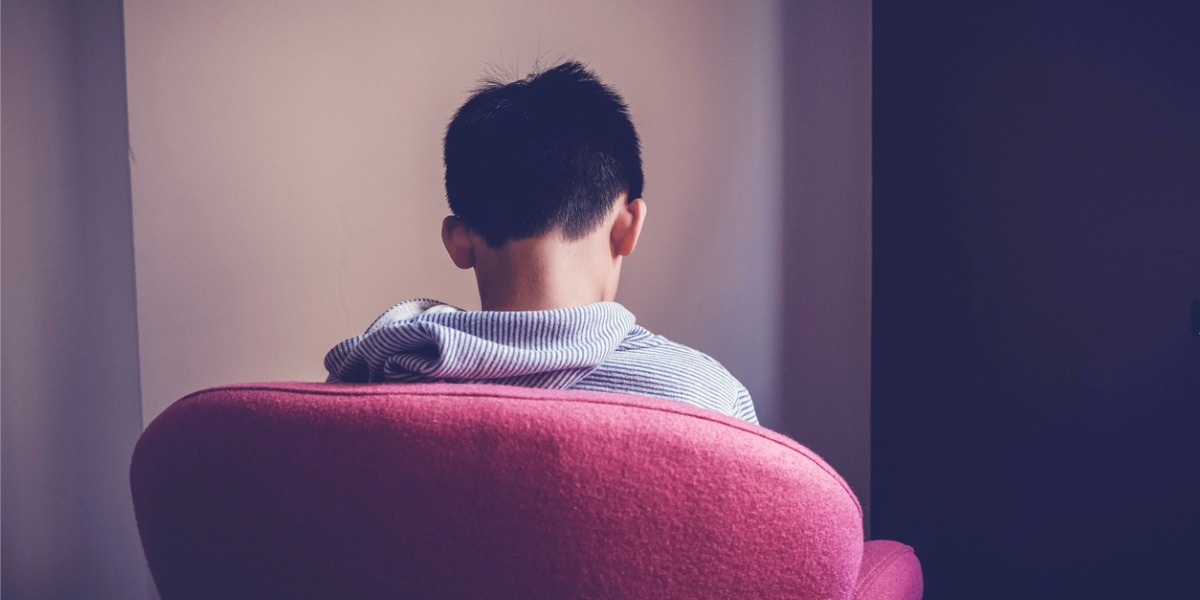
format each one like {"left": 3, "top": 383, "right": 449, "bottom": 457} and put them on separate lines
{"left": 475, "top": 235, "right": 619, "bottom": 311}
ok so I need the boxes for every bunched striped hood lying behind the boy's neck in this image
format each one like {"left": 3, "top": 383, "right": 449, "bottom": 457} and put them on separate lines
{"left": 325, "top": 299, "right": 636, "bottom": 389}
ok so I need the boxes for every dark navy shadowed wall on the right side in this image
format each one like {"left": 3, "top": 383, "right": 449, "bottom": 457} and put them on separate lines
{"left": 871, "top": 0, "right": 1200, "bottom": 600}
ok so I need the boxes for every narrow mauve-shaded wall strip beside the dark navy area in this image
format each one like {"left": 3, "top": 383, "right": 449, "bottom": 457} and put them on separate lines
{"left": 780, "top": 0, "right": 871, "bottom": 535}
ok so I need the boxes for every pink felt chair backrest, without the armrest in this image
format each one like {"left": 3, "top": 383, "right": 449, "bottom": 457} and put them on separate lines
{"left": 131, "top": 383, "right": 863, "bottom": 600}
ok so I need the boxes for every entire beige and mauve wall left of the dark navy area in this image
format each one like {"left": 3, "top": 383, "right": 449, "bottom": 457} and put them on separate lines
{"left": 0, "top": 0, "right": 870, "bottom": 598}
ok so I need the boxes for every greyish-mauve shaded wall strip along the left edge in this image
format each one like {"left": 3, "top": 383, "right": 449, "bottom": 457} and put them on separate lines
{"left": 0, "top": 0, "right": 146, "bottom": 600}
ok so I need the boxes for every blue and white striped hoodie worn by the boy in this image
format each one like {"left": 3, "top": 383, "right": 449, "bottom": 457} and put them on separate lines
{"left": 325, "top": 299, "right": 758, "bottom": 422}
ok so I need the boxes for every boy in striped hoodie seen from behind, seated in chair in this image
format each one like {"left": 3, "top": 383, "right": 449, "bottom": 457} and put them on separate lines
{"left": 325, "top": 62, "right": 758, "bottom": 422}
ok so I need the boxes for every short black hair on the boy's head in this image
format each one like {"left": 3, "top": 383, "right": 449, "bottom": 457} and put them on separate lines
{"left": 443, "top": 61, "right": 643, "bottom": 247}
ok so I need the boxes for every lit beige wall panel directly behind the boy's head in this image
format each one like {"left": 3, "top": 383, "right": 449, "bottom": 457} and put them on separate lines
{"left": 125, "top": 0, "right": 781, "bottom": 426}
